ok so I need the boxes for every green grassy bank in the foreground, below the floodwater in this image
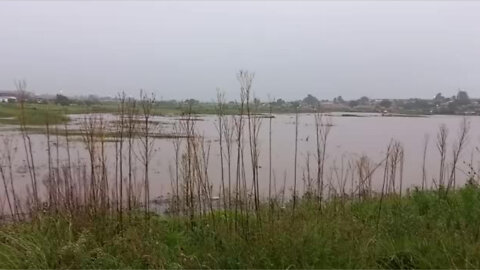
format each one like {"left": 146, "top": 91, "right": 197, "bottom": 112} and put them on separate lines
{"left": 0, "top": 186, "right": 480, "bottom": 269}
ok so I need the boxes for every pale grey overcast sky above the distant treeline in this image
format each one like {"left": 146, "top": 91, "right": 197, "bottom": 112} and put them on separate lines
{"left": 0, "top": 1, "right": 480, "bottom": 100}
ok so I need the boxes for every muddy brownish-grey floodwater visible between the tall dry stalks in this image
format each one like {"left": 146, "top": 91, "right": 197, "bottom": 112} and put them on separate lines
{"left": 0, "top": 113, "right": 480, "bottom": 205}
